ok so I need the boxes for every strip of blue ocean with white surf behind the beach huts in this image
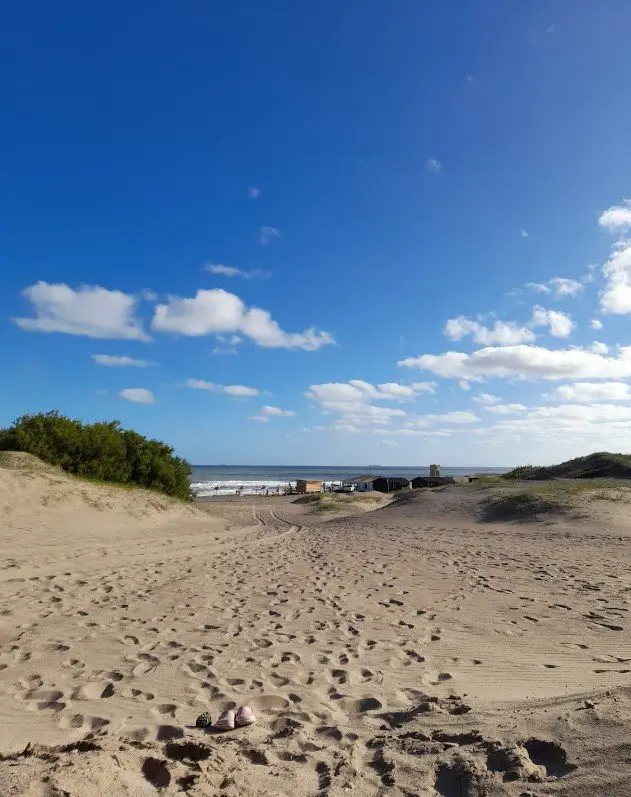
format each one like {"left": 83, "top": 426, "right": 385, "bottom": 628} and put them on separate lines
{"left": 191, "top": 465, "right": 510, "bottom": 497}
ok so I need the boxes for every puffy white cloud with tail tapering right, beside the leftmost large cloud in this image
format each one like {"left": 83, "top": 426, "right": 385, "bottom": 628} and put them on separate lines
{"left": 152, "top": 288, "right": 335, "bottom": 351}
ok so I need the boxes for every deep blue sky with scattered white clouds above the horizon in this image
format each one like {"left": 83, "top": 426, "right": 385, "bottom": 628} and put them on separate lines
{"left": 0, "top": 0, "right": 631, "bottom": 466}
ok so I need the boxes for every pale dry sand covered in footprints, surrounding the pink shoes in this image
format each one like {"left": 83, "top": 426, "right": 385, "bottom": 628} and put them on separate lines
{"left": 0, "top": 460, "right": 631, "bottom": 797}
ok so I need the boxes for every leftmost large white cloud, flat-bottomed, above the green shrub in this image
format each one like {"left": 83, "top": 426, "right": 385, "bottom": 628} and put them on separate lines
{"left": 13, "top": 281, "right": 149, "bottom": 341}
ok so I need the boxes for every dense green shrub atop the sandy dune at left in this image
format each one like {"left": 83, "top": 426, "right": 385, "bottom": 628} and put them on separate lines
{"left": 0, "top": 412, "right": 192, "bottom": 500}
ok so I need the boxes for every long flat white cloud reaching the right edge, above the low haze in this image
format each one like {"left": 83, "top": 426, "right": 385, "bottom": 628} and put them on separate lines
{"left": 398, "top": 345, "right": 631, "bottom": 380}
